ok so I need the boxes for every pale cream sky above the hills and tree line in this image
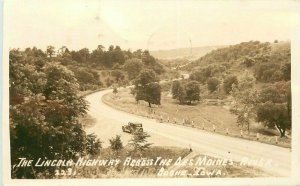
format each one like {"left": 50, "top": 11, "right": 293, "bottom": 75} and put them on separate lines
{"left": 4, "top": 0, "right": 295, "bottom": 50}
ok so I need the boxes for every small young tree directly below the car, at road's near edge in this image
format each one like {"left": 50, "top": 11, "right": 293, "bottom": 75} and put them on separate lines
{"left": 130, "top": 132, "right": 152, "bottom": 153}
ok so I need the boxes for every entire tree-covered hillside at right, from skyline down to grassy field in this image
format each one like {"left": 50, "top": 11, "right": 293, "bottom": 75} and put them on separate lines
{"left": 172, "top": 41, "right": 291, "bottom": 137}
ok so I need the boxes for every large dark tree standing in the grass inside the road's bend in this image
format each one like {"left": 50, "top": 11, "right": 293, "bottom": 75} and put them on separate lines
{"left": 133, "top": 70, "right": 161, "bottom": 107}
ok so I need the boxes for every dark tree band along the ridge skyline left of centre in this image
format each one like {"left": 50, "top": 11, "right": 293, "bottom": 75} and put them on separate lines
{"left": 53, "top": 45, "right": 165, "bottom": 74}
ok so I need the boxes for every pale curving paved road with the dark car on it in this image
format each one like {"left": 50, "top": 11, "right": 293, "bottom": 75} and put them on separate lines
{"left": 86, "top": 90, "right": 291, "bottom": 176}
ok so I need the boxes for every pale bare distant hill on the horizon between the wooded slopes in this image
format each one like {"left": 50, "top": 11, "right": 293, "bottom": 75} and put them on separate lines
{"left": 150, "top": 46, "right": 225, "bottom": 60}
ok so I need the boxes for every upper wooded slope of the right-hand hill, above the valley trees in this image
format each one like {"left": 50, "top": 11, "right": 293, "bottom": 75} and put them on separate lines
{"left": 180, "top": 41, "right": 291, "bottom": 83}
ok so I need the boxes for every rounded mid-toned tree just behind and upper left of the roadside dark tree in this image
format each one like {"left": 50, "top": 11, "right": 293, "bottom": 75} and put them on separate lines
{"left": 124, "top": 58, "right": 143, "bottom": 80}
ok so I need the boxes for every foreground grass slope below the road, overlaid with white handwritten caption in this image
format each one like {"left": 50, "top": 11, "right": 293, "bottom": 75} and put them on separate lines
{"left": 39, "top": 146, "right": 272, "bottom": 179}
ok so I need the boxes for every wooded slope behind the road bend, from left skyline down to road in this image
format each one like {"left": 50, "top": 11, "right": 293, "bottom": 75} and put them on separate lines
{"left": 21, "top": 45, "right": 166, "bottom": 91}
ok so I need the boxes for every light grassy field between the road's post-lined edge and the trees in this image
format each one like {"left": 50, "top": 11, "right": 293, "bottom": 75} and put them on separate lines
{"left": 103, "top": 89, "right": 291, "bottom": 148}
